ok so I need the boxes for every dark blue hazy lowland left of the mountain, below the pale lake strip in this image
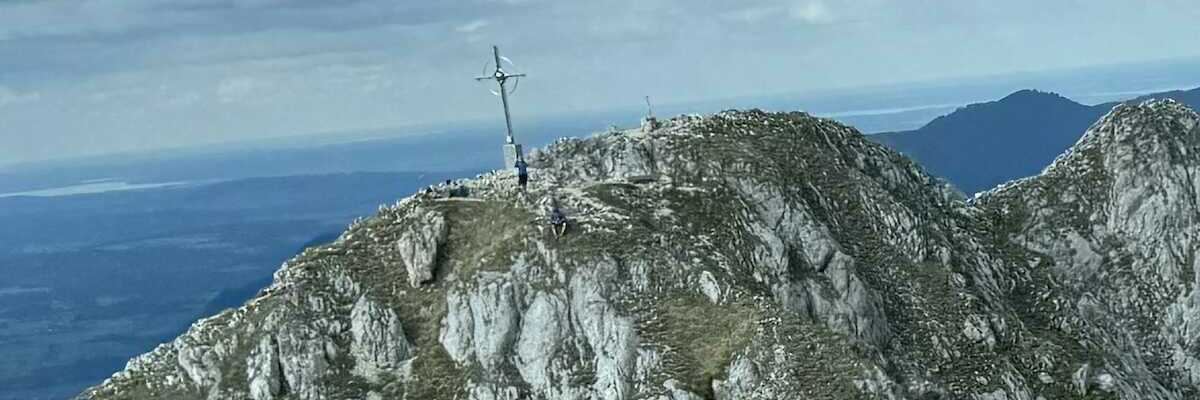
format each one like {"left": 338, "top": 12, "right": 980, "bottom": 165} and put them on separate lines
{"left": 0, "top": 173, "right": 451, "bottom": 399}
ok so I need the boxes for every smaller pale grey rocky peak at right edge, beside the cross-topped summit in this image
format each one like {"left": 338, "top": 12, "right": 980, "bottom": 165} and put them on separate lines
{"left": 976, "top": 101, "right": 1200, "bottom": 399}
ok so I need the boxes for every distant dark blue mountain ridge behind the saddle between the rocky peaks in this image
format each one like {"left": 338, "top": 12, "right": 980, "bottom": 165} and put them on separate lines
{"left": 869, "top": 88, "right": 1200, "bottom": 195}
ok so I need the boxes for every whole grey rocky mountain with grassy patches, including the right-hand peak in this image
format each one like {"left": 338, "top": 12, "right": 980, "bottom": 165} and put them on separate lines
{"left": 82, "top": 102, "right": 1200, "bottom": 400}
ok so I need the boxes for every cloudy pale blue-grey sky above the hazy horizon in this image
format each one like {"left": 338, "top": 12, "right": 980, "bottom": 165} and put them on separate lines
{"left": 0, "top": 0, "right": 1200, "bottom": 165}
